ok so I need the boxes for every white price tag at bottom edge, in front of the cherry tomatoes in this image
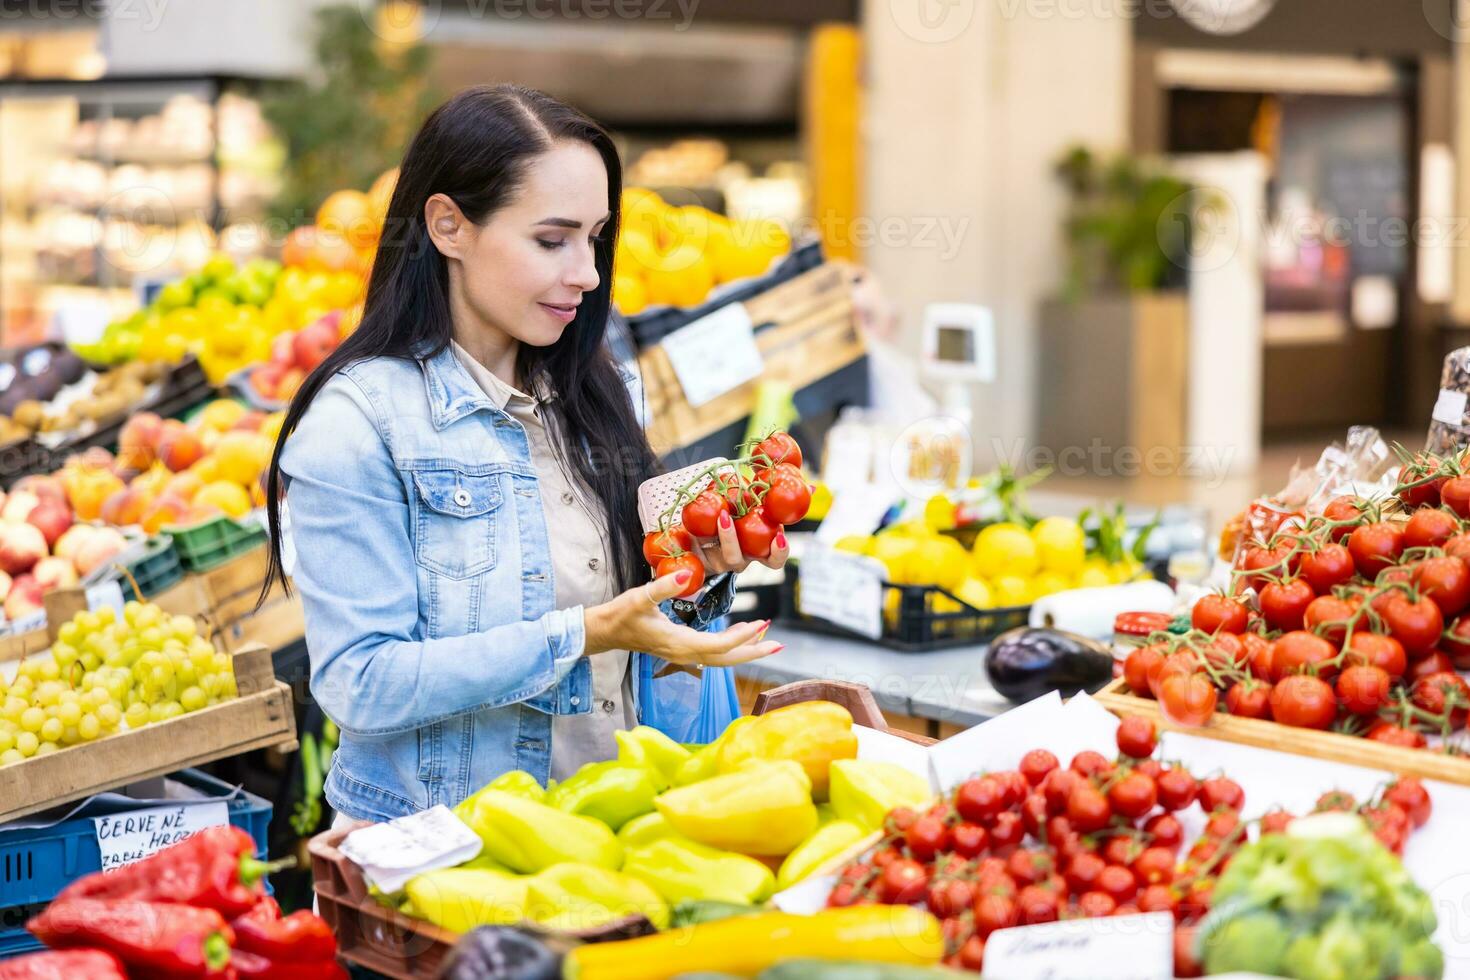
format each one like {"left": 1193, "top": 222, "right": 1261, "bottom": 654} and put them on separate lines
{"left": 982, "top": 912, "right": 1175, "bottom": 980}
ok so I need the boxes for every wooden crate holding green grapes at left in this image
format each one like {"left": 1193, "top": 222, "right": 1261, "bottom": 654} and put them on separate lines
{"left": 0, "top": 646, "right": 297, "bottom": 823}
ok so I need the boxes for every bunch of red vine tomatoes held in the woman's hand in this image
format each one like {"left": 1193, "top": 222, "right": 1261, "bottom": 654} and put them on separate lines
{"left": 644, "top": 432, "right": 811, "bottom": 598}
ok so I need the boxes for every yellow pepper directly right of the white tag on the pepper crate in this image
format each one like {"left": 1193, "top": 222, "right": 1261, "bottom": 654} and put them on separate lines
{"left": 466, "top": 789, "right": 623, "bottom": 874}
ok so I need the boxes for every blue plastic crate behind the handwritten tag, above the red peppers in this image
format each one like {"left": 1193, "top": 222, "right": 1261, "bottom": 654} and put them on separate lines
{"left": 0, "top": 768, "right": 272, "bottom": 959}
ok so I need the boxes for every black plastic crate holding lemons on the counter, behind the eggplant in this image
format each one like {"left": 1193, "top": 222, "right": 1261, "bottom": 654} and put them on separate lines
{"left": 781, "top": 563, "right": 1030, "bottom": 654}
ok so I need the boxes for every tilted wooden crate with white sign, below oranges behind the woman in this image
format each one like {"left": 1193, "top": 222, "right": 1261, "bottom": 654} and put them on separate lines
{"left": 638, "top": 262, "right": 866, "bottom": 454}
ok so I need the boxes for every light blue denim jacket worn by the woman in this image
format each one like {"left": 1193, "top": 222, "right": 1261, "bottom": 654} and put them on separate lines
{"left": 281, "top": 350, "right": 731, "bottom": 820}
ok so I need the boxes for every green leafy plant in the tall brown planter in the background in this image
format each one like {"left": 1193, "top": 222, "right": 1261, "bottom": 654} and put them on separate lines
{"left": 1055, "top": 147, "right": 1194, "bottom": 301}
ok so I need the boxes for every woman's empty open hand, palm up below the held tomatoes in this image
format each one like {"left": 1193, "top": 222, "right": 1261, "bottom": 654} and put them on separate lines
{"left": 584, "top": 572, "right": 782, "bottom": 667}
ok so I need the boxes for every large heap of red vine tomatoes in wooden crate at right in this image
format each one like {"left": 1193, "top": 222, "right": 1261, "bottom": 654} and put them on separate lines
{"left": 1123, "top": 457, "right": 1470, "bottom": 748}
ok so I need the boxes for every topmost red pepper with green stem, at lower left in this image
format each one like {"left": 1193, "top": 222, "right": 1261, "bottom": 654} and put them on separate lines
{"left": 56, "top": 827, "right": 287, "bottom": 920}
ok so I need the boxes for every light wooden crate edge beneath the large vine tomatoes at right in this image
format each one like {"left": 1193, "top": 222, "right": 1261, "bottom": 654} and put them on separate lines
{"left": 1092, "top": 677, "right": 1470, "bottom": 786}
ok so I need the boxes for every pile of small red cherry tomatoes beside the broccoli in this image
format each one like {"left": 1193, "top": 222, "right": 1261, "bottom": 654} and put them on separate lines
{"left": 828, "top": 716, "right": 1430, "bottom": 977}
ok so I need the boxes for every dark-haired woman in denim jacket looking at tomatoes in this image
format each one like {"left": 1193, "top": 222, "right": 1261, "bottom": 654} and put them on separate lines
{"left": 268, "top": 85, "right": 786, "bottom": 820}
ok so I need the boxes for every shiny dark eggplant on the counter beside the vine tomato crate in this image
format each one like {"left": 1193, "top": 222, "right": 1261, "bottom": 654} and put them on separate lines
{"left": 985, "top": 626, "right": 1113, "bottom": 704}
